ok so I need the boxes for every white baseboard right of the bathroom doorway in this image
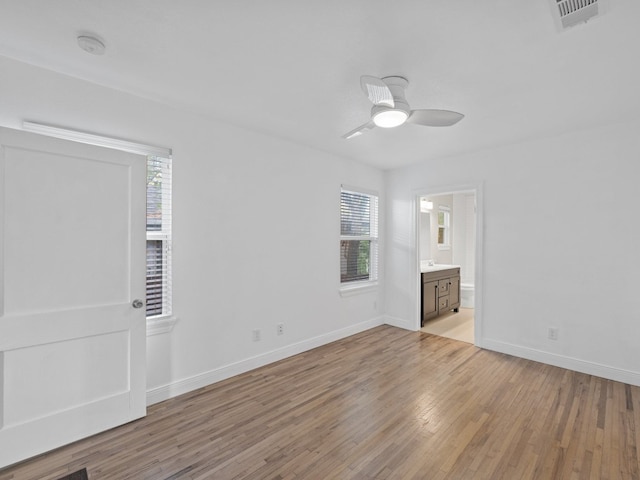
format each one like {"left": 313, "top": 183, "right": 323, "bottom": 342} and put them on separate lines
{"left": 482, "top": 338, "right": 640, "bottom": 386}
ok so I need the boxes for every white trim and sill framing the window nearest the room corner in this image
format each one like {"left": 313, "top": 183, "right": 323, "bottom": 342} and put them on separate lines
{"left": 338, "top": 185, "right": 380, "bottom": 297}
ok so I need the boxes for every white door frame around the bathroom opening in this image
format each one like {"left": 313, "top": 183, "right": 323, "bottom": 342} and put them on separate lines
{"left": 412, "top": 183, "right": 484, "bottom": 347}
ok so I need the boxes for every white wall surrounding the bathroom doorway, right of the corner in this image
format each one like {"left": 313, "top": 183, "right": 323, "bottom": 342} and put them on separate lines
{"left": 385, "top": 121, "right": 640, "bottom": 385}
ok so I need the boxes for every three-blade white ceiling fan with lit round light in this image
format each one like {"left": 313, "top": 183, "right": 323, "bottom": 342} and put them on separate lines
{"left": 342, "top": 75, "right": 464, "bottom": 139}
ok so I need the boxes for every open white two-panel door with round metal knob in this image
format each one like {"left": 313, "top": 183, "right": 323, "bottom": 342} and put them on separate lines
{"left": 0, "top": 128, "right": 146, "bottom": 468}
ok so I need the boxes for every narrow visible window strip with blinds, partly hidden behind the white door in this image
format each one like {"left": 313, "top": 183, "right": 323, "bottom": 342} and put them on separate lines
{"left": 147, "top": 155, "right": 172, "bottom": 318}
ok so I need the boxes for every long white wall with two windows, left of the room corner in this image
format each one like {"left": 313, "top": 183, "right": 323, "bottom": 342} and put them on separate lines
{"left": 0, "top": 57, "right": 384, "bottom": 402}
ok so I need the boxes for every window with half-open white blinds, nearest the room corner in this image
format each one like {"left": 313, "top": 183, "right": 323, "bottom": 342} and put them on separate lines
{"left": 340, "top": 189, "right": 378, "bottom": 284}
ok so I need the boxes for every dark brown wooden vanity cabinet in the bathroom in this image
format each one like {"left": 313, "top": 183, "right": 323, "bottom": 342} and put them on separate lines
{"left": 421, "top": 267, "right": 460, "bottom": 326}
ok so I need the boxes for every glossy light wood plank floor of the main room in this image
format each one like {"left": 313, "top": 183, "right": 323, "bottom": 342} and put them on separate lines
{"left": 0, "top": 326, "right": 640, "bottom": 480}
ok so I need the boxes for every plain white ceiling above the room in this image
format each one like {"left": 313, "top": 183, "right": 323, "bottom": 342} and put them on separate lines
{"left": 0, "top": 0, "right": 640, "bottom": 169}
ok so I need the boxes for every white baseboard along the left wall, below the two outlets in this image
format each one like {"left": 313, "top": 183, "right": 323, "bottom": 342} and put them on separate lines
{"left": 147, "top": 317, "right": 385, "bottom": 405}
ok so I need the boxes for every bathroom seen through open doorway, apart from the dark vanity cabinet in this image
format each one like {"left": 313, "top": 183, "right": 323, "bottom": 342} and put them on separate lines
{"left": 417, "top": 189, "right": 478, "bottom": 344}
